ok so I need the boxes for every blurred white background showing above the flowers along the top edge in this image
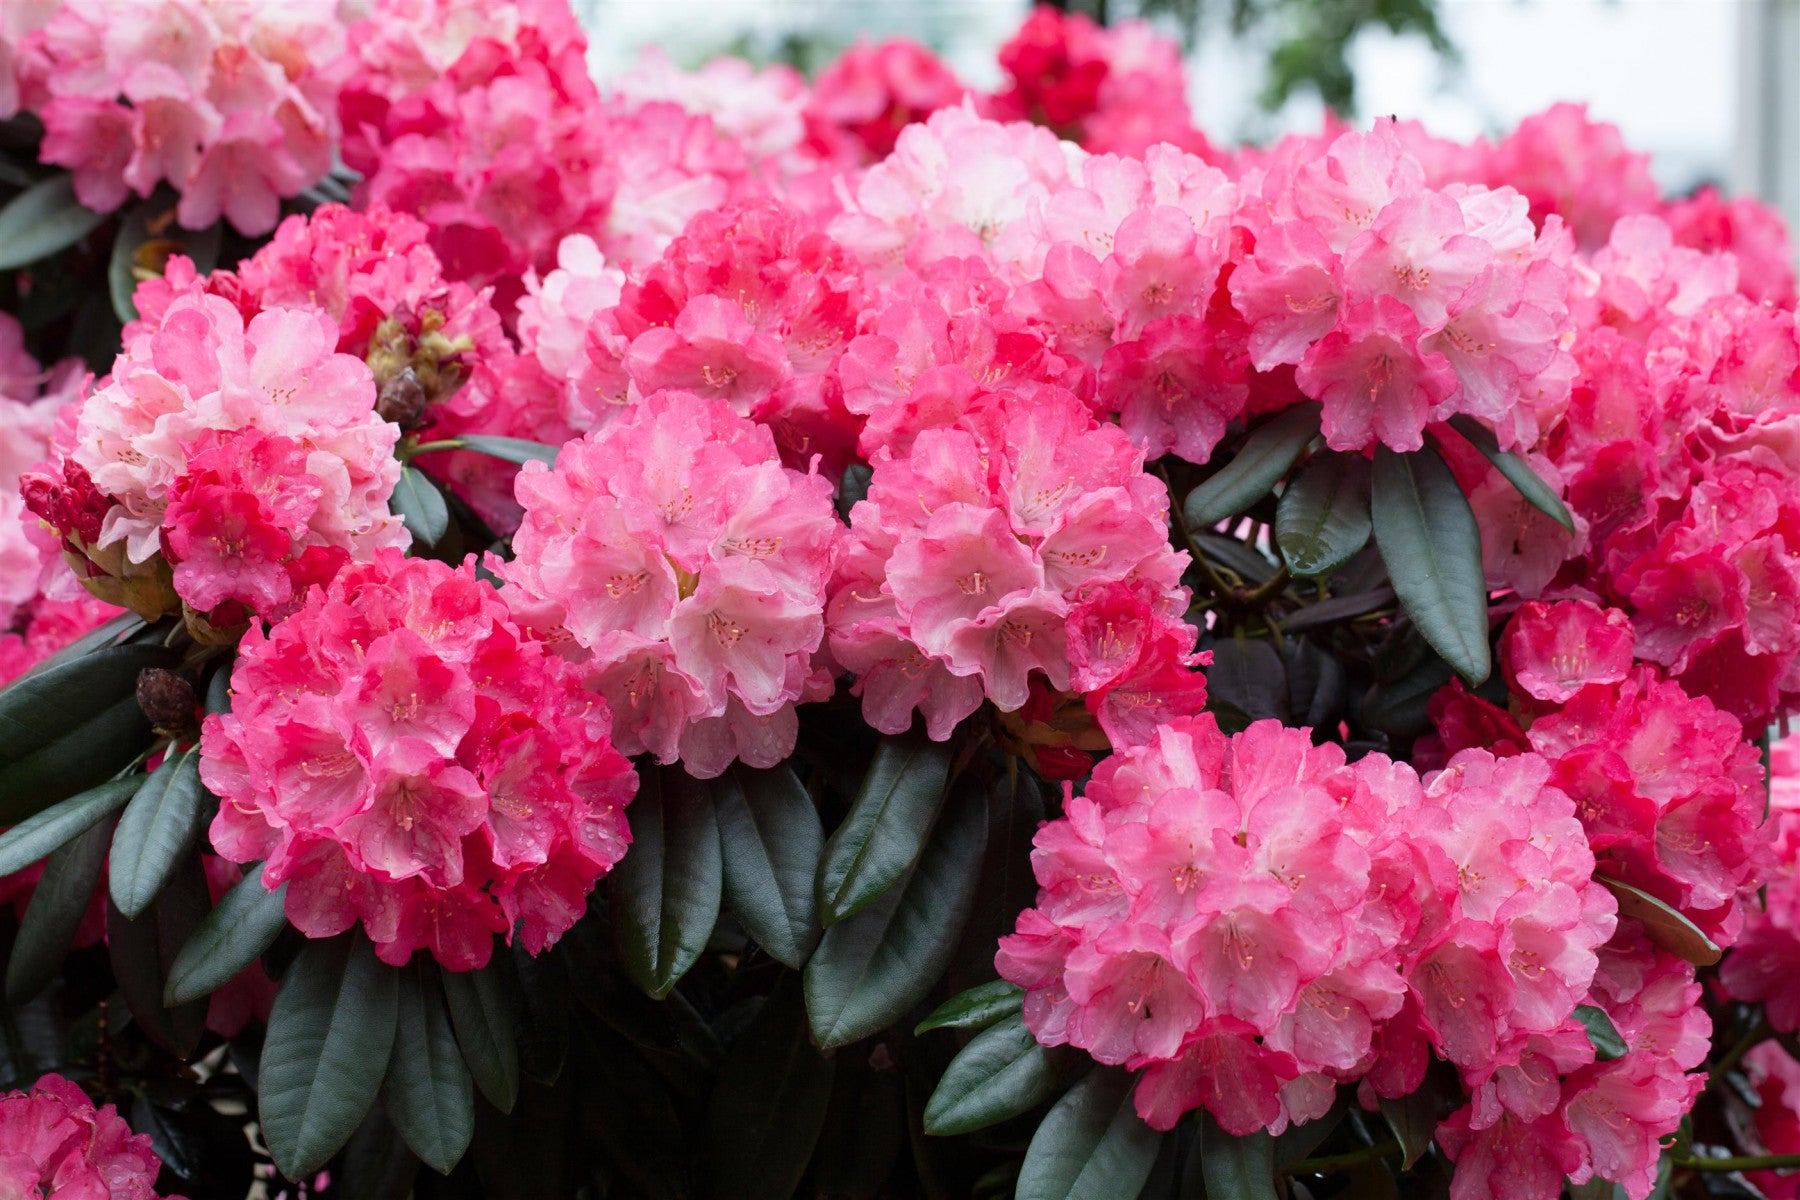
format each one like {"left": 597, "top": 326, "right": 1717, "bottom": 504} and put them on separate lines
{"left": 574, "top": 0, "right": 1800, "bottom": 244}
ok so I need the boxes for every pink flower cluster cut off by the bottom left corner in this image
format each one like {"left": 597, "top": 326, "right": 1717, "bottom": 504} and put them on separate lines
{"left": 0, "top": 1074, "right": 179, "bottom": 1200}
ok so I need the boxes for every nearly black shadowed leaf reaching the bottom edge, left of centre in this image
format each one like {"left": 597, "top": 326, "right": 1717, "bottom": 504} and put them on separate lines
{"left": 700, "top": 977, "right": 832, "bottom": 1200}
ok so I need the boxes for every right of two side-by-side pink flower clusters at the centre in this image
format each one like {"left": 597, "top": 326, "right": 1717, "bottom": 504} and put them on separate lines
{"left": 828, "top": 387, "right": 1206, "bottom": 745}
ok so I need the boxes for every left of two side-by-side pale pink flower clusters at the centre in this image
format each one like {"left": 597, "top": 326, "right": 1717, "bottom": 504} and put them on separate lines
{"left": 495, "top": 390, "right": 841, "bottom": 777}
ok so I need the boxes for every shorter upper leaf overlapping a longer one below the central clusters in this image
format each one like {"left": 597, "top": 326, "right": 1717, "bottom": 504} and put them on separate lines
{"left": 819, "top": 729, "right": 950, "bottom": 927}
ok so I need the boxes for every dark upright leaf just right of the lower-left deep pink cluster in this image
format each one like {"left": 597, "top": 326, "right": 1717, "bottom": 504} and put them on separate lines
{"left": 607, "top": 766, "right": 725, "bottom": 1000}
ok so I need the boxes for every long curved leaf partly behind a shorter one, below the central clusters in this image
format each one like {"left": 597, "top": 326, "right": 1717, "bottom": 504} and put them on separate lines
{"left": 806, "top": 788, "right": 988, "bottom": 1047}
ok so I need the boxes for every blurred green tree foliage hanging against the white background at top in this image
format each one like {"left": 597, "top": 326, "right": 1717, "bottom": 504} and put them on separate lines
{"left": 1049, "top": 0, "right": 1456, "bottom": 117}
